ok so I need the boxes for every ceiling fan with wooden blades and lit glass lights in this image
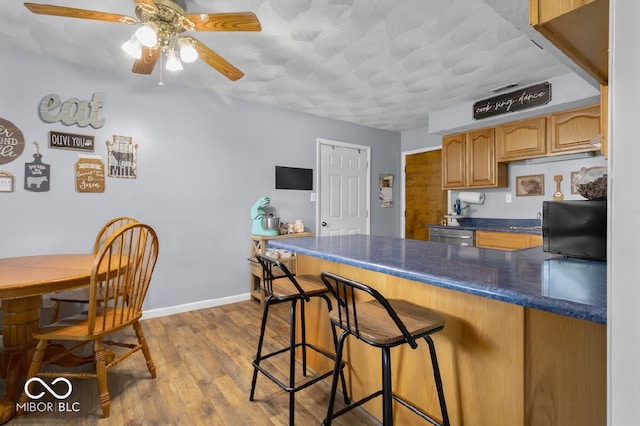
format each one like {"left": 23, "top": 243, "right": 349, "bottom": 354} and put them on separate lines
{"left": 24, "top": 0, "right": 261, "bottom": 81}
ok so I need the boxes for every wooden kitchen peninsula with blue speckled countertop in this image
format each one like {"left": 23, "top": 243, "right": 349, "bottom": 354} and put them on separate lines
{"left": 269, "top": 235, "right": 607, "bottom": 426}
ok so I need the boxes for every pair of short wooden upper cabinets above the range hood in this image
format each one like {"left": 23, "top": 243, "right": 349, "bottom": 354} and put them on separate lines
{"left": 496, "top": 105, "right": 601, "bottom": 162}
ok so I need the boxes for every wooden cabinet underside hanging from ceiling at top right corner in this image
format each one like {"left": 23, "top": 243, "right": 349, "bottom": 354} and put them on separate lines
{"left": 529, "top": 0, "right": 609, "bottom": 85}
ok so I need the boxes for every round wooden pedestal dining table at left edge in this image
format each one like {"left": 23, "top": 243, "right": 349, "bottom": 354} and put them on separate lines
{"left": 0, "top": 254, "right": 105, "bottom": 424}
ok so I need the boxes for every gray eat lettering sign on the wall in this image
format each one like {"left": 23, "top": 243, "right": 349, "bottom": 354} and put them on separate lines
{"left": 38, "top": 93, "right": 104, "bottom": 129}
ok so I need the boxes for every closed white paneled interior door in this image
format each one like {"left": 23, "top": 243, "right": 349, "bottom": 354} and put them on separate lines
{"left": 316, "top": 139, "right": 371, "bottom": 236}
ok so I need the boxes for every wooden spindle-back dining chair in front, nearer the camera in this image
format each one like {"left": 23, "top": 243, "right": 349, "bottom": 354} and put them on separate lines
{"left": 18, "top": 223, "right": 158, "bottom": 417}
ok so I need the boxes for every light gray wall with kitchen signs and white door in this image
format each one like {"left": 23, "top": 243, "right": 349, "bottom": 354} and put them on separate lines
{"left": 0, "top": 49, "right": 400, "bottom": 310}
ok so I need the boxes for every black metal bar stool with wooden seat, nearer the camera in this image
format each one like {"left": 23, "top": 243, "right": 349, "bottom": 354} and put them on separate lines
{"left": 320, "top": 272, "right": 449, "bottom": 426}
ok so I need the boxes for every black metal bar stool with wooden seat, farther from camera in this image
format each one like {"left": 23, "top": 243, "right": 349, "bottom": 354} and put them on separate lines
{"left": 249, "top": 253, "right": 349, "bottom": 425}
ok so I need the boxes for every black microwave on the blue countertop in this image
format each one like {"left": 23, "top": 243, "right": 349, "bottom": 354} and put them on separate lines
{"left": 542, "top": 200, "right": 607, "bottom": 260}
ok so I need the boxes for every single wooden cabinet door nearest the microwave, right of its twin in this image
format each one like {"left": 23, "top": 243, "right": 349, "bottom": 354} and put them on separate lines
{"left": 549, "top": 105, "right": 600, "bottom": 154}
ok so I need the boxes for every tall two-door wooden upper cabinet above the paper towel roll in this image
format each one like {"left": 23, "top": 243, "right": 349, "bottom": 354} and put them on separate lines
{"left": 442, "top": 128, "right": 508, "bottom": 189}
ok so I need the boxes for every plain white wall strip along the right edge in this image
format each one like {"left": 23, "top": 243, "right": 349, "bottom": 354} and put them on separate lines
{"left": 607, "top": 0, "right": 640, "bottom": 426}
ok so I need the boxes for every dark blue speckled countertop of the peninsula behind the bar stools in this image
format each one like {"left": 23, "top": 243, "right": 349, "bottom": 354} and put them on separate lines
{"left": 268, "top": 235, "right": 607, "bottom": 324}
